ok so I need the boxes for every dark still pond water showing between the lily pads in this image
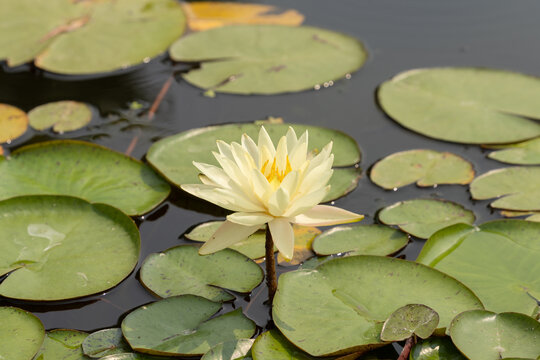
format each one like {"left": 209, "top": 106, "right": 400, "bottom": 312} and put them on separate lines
{"left": 0, "top": 0, "right": 540, "bottom": 354}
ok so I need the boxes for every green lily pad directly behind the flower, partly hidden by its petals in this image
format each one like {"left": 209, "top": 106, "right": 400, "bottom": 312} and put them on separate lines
{"left": 146, "top": 123, "right": 360, "bottom": 201}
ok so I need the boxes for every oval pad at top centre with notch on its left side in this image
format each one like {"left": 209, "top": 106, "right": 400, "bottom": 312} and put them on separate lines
{"left": 169, "top": 25, "right": 367, "bottom": 95}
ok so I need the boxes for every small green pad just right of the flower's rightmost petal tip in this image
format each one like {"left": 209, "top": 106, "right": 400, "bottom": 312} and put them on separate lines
{"left": 379, "top": 199, "right": 475, "bottom": 239}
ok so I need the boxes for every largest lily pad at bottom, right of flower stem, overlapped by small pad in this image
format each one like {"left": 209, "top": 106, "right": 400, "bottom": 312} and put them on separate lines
{"left": 272, "top": 255, "right": 483, "bottom": 356}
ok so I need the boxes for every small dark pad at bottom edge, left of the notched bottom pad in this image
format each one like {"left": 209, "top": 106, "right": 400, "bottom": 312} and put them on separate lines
{"left": 82, "top": 328, "right": 131, "bottom": 358}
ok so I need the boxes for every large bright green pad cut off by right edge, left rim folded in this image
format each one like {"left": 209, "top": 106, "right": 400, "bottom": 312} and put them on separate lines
{"left": 417, "top": 220, "right": 540, "bottom": 315}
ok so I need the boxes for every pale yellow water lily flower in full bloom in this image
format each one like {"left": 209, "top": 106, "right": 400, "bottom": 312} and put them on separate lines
{"left": 182, "top": 127, "right": 363, "bottom": 259}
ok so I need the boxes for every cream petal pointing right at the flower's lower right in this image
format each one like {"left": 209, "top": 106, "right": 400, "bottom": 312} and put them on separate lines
{"left": 291, "top": 205, "right": 364, "bottom": 226}
